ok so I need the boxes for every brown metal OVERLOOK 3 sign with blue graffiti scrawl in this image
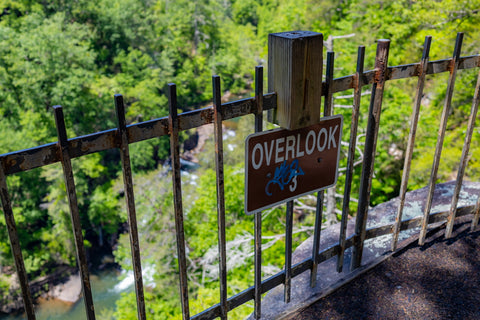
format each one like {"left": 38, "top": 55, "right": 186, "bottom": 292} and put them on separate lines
{"left": 245, "top": 115, "right": 343, "bottom": 214}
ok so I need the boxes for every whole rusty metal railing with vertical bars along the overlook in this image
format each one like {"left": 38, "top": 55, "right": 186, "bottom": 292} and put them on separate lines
{"left": 0, "top": 33, "right": 480, "bottom": 319}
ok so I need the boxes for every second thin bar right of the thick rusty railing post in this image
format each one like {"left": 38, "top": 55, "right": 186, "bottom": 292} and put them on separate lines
{"left": 418, "top": 32, "right": 463, "bottom": 245}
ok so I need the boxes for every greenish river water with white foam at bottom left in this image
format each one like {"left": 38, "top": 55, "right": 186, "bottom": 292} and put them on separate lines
{"left": 0, "top": 270, "right": 134, "bottom": 320}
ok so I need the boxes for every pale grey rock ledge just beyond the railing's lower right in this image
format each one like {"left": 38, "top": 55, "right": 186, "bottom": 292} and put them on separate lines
{"left": 249, "top": 181, "right": 480, "bottom": 320}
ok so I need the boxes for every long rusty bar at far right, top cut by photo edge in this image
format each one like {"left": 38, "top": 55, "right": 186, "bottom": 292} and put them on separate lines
{"left": 445, "top": 68, "right": 480, "bottom": 239}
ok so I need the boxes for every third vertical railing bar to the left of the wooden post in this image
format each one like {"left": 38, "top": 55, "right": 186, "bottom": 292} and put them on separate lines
{"left": 168, "top": 83, "right": 190, "bottom": 320}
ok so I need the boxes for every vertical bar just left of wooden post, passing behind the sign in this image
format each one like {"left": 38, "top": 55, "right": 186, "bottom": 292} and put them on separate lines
{"left": 254, "top": 66, "right": 263, "bottom": 319}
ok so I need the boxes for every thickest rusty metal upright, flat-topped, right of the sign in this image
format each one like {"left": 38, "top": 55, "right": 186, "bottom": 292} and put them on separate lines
{"left": 351, "top": 40, "right": 390, "bottom": 269}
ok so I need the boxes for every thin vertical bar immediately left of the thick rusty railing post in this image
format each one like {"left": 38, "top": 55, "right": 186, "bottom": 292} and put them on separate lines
{"left": 337, "top": 46, "right": 365, "bottom": 272}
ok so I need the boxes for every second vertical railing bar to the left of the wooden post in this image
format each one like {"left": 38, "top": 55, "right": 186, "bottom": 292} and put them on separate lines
{"left": 212, "top": 76, "right": 228, "bottom": 319}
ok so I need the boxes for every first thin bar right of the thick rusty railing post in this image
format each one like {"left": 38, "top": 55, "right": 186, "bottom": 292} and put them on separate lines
{"left": 392, "top": 36, "right": 432, "bottom": 251}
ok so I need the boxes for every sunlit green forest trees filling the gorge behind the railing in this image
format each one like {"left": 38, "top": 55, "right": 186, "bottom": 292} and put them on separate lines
{"left": 0, "top": 0, "right": 480, "bottom": 319}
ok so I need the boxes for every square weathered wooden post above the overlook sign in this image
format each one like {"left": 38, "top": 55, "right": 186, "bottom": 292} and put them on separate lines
{"left": 268, "top": 31, "right": 323, "bottom": 130}
